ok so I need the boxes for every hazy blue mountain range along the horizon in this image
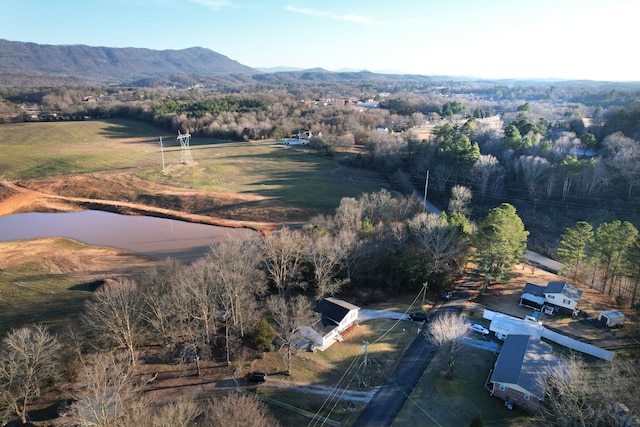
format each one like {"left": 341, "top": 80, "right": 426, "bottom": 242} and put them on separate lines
{"left": 0, "top": 39, "right": 637, "bottom": 88}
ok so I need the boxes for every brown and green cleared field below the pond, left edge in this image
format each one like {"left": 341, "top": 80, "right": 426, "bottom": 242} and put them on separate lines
{"left": 0, "top": 238, "right": 153, "bottom": 336}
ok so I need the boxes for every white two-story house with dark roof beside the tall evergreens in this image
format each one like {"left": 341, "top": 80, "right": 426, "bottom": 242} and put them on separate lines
{"left": 520, "top": 281, "right": 582, "bottom": 314}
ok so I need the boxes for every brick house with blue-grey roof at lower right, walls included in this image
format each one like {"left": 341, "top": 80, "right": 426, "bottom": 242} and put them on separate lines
{"left": 487, "top": 335, "right": 558, "bottom": 414}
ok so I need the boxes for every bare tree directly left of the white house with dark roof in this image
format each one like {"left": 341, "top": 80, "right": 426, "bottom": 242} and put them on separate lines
{"left": 267, "top": 295, "right": 313, "bottom": 374}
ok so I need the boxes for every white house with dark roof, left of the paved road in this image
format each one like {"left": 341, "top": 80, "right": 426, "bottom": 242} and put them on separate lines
{"left": 301, "top": 298, "right": 360, "bottom": 350}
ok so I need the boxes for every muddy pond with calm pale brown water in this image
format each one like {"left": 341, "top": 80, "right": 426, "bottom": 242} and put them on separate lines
{"left": 0, "top": 210, "right": 258, "bottom": 261}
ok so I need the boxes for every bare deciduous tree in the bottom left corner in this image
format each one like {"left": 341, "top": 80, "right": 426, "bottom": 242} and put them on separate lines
{"left": 0, "top": 325, "right": 61, "bottom": 424}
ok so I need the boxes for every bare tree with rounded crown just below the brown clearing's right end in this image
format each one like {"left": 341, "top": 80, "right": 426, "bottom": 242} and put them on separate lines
{"left": 82, "top": 280, "right": 143, "bottom": 365}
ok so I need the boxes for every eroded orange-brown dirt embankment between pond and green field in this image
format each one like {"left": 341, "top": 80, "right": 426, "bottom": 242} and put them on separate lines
{"left": 0, "top": 174, "right": 310, "bottom": 232}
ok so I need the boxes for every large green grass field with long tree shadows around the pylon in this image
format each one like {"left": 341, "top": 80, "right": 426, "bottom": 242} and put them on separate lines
{"left": 0, "top": 120, "right": 385, "bottom": 212}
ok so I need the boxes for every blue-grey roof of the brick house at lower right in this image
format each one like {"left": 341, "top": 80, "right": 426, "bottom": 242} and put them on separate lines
{"left": 491, "top": 335, "right": 556, "bottom": 400}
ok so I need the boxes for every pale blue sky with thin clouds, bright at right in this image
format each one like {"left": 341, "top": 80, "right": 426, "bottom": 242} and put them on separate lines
{"left": 0, "top": 0, "right": 640, "bottom": 81}
